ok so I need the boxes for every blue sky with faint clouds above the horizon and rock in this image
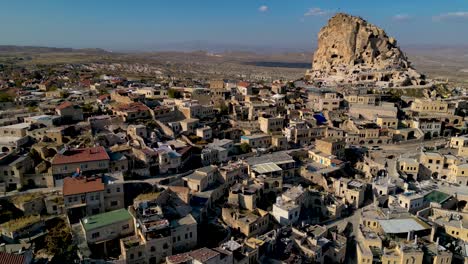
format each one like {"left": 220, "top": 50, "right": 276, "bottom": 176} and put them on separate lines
{"left": 0, "top": 0, "right": 468, "bottom": 50}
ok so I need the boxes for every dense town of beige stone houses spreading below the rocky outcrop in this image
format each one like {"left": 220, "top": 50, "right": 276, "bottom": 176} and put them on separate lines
{"left": 0, "top": 14, "right": 468, "bottom": 264}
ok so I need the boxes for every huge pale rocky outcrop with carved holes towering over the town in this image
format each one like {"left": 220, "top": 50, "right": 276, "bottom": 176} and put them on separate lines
{"left": 307, "top": 13, "right": 427, "bottom": 87}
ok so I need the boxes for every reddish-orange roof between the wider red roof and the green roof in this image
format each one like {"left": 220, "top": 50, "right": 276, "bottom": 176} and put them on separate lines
{"left": 62, "top": 177, "right": 104, "bottom": 196}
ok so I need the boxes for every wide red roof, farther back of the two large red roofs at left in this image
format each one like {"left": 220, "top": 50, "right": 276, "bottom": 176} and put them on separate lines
{"left": 52, "top": 147, "right": 110, "bottom": 165}
